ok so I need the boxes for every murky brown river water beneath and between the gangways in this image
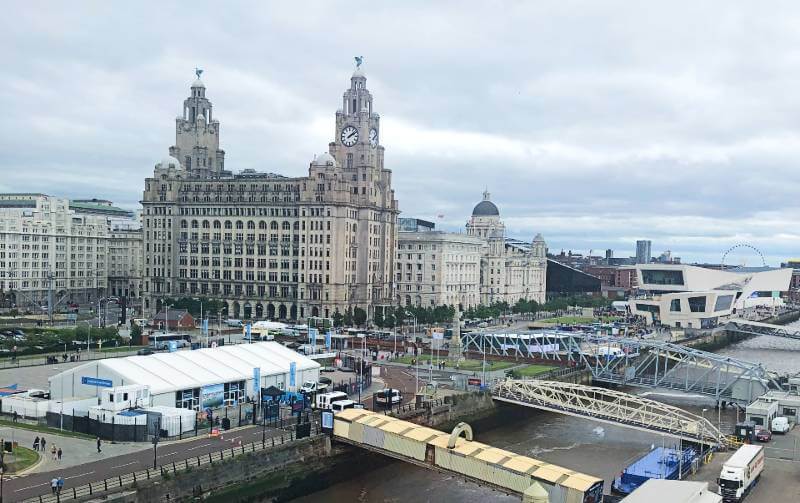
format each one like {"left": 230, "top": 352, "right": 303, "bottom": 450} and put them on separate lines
{"left": 294, "top": 322, "right": 800, "bottom": 503}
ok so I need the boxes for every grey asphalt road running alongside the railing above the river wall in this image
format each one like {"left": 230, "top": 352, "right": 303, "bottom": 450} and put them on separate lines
{"left": 4, "top": 426, "right": 288, "bottom": 501}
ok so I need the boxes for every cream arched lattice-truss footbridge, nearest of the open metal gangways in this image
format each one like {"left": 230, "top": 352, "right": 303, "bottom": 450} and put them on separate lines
{"left": 491, "top": 379, "right": 728, "bottom": 446}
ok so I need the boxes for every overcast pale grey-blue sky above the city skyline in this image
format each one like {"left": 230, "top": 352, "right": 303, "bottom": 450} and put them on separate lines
{"left": 0, "top": 0, "right": 800, "bottom": 265}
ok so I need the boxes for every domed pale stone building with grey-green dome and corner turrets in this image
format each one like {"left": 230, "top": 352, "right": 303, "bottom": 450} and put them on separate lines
{"left": 467, "top": 192, "right": 547, "bottom": 305}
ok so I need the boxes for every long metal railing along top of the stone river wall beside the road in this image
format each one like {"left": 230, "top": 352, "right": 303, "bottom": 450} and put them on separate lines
{"left": 23, "top": 422, "right": 321, "bottom": 503}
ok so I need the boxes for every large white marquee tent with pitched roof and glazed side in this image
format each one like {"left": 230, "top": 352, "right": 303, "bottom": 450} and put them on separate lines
{"left": 49, "top": 342, "right": 320, "bottom": 410}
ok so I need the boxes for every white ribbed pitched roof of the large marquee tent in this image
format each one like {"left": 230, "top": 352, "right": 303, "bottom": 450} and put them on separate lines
{"left": 51, "top": 342, "right": 320, "bottom": 394}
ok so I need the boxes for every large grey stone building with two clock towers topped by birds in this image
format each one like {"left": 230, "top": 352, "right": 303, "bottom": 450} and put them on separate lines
{"left": 142, "top": 69, "right": 398, "bottom": 320}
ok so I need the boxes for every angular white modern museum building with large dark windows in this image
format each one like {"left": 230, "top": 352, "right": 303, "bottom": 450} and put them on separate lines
{"left": 630, "top": 264, "right": 792, "bottom": 328}
